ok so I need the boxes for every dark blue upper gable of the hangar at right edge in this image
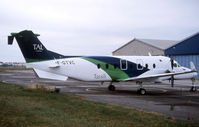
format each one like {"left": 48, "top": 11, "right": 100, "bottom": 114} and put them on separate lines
{"left": 164, "top": 32, "right": 199, "bottom": 56}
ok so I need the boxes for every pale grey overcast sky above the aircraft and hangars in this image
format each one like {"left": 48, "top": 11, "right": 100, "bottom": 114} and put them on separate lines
{"left": 0, "top": 0, "right": 199, "bottom": 61}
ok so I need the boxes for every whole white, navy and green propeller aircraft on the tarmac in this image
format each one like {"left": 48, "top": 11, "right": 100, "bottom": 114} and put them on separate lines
{"left": 8, "top": 30, "right": 197, "bottom": 94}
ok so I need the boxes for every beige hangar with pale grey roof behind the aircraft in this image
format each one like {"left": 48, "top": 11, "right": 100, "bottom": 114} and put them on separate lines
{"left": 112, "top": 38, "right": 177, "bottom": 56}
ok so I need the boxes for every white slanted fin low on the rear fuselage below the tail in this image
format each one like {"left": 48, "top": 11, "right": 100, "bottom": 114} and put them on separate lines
{"left": 34, "top": 69, "right": 68, "bottom": 81}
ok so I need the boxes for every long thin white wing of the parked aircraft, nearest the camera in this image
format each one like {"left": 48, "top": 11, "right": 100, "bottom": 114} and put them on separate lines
{"left": 123, "top": 70, "right": 197, "bottom": 81}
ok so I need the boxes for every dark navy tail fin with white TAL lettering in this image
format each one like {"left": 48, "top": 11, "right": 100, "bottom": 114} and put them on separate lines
{"left": 8, "top": 30, "right": 63, "bottom": 63}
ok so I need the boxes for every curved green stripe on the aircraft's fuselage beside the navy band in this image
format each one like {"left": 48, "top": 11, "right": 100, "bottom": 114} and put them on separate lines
{"left": 82, "top": 57, "right": 129, "bottom": 81}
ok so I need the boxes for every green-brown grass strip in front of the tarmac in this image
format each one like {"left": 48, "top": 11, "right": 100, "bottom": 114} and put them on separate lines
{"left": 0, "top": 82, "right": 199, "bottom": 127}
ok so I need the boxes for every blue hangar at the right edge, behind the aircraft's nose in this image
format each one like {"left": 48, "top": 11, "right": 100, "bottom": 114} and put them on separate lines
{"left": 165, "top": 33, "right": 199, "bottom": 79}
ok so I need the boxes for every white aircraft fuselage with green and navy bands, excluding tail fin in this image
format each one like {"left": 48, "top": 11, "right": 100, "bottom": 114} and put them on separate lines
{"left": 27, "top": 56, "right": 197, "bottom": 82}
